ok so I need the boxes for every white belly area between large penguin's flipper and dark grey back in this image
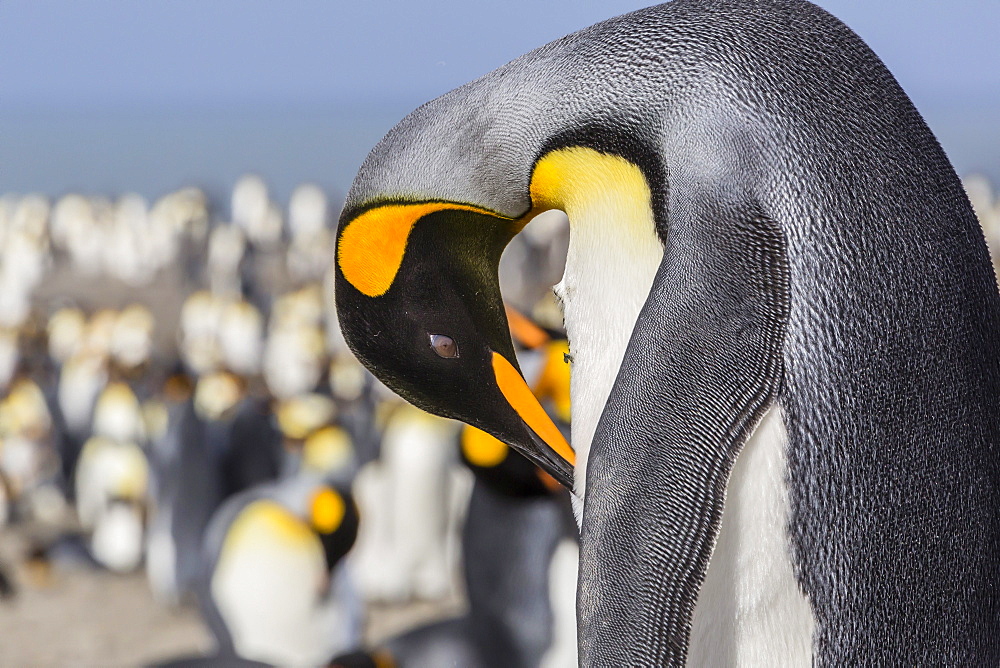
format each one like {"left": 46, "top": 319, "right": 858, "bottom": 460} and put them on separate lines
{"left": 688, "top": 406, "right": 815, "bottom": 666}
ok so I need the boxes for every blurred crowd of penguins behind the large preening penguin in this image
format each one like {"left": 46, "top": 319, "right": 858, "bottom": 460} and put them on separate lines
{"left": 0, "top": 167, "right": 576, "bottom": 666}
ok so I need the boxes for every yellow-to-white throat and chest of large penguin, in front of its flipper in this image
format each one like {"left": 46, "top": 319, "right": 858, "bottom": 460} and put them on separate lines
{"left": 531, "top": 147, "right": 663, "bottom": 522}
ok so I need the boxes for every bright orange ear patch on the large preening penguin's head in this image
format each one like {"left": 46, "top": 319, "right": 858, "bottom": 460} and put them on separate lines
{"left": 337, "top": 202, "right": 502, "bottom": 297}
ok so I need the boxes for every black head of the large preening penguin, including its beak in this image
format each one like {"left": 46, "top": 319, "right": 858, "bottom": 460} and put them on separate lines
{"left": 336, "top": 202, "right": 574, "bottom": 486}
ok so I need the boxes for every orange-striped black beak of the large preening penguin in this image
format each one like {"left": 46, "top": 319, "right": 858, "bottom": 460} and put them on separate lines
{"left": 493, "top": 351, "right": 576, "bottom": 489}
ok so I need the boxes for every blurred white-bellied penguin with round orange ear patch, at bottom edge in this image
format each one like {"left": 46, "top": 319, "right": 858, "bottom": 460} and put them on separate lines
{"left": 199, "top": 476, "right": 362, "bottom": 666}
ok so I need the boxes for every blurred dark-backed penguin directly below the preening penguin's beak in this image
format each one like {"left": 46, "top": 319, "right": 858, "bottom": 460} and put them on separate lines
{"left": 332, "top": 426, "right": 577, "bottom": 668}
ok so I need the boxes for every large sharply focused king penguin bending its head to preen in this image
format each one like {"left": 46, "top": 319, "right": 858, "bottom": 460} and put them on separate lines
{"left": 336, "top": 0, "right": 1000, "bottom": 666}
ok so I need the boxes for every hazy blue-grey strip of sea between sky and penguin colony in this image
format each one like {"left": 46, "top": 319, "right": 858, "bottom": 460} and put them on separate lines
{"left": 0, "top": 103, "right": 1000, "bottom": 217}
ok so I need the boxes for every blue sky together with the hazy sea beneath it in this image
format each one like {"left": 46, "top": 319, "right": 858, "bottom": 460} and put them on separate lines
{"left": 0, "top": 0, "right": 1000, "bottom": 201}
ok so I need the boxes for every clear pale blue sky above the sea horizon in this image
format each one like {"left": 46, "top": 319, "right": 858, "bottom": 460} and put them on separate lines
{"left": 0, "top": 0, "right": 1000, "bottom": 110}
